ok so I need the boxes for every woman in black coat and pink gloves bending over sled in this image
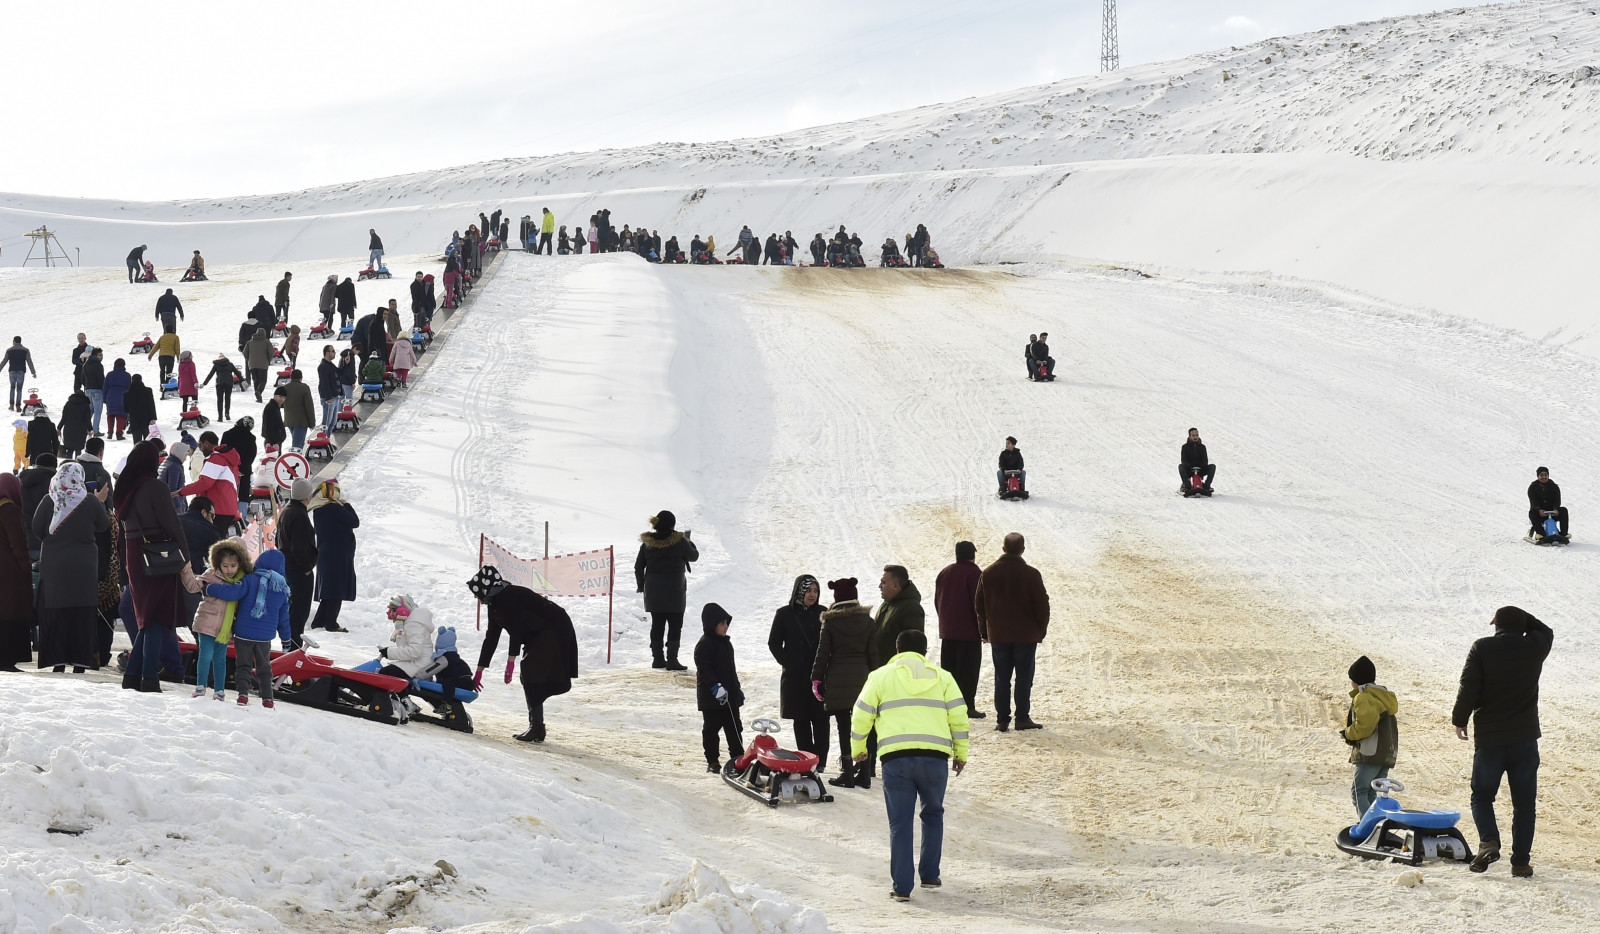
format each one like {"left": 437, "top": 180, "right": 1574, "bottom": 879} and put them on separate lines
{"left": 467, "top": 565, "right": 578, "bottom": 742}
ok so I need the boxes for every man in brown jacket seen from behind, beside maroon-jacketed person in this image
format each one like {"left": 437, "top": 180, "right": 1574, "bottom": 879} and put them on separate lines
{"left": 976, "top": 533, "right": 1050, "bottom": 732}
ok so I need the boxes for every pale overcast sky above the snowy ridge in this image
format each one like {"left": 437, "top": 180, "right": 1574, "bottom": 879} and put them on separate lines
{"left": 0, "top": 0, "right": 1497, "bottom": 198}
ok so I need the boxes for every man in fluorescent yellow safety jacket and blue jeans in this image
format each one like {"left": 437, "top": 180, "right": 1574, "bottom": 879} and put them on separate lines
{"left": 850, "top": 629, "right": 970, "bottom": 902}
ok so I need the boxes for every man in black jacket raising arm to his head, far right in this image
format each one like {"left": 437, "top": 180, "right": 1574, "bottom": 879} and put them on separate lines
{"left": 1451, "top": 606, "right": 1555, "bottom": 876}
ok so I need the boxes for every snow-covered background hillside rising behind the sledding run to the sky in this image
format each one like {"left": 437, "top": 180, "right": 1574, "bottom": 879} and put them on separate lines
{"left": 0, "top": 0, "right": 1600, "bottom": 353}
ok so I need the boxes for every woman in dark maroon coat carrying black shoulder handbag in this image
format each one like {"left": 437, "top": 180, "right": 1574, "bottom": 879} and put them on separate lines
{"left": 112, "top": 441, "right": 189, "bottom": 693}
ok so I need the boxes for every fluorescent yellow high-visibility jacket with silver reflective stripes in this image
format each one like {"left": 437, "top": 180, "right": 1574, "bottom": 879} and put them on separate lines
{"left": 850, "top": 653, "right": 970, "bottom": 761}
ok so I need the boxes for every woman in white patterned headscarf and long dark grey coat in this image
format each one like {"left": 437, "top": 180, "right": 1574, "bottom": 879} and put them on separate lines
{"left": 34, "top": 461, "right": 110, "bottom": 673}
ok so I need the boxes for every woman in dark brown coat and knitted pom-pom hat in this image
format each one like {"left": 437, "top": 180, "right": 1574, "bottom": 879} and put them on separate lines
{"left": 811, "top": 577, "right": 878, "bottom": 788}
